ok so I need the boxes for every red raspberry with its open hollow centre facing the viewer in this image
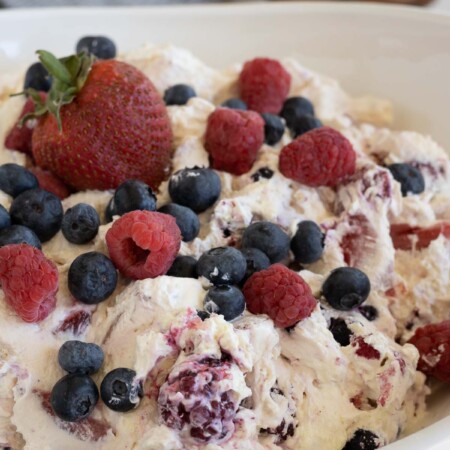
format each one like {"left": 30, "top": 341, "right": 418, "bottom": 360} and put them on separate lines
{"left": 106, "top": 211, "right": 181, "bottom": 280}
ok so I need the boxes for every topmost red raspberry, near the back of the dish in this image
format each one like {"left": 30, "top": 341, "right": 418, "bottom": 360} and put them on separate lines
{"left": 239, "top": 58, "right": 291, "bottom": 114}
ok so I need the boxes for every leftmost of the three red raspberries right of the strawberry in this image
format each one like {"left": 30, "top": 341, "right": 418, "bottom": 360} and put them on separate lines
{"left": 205, "top": 108, "right": 264, "bottom": 175}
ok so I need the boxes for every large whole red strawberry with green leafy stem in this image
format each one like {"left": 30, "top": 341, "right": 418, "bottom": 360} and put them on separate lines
{"left": 28, "top": 51, "right": 172, "bottom": 190}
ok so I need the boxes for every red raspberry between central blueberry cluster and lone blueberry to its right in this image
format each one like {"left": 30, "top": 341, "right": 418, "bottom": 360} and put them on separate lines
{"left": 243, "top": 264, "right": 317, "bottom": 328}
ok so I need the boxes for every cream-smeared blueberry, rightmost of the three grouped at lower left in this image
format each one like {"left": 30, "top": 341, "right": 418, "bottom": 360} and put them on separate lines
{"left": 100, "top": 368, "right": 144, "bottom": 412}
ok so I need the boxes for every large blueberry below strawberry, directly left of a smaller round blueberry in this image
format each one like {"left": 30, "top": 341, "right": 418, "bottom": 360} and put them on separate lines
{"left": 9, "top": 189, "right": 63, "bottom": 242}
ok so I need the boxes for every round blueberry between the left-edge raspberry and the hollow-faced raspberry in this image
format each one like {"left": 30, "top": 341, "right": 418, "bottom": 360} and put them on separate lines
{"left": 68, "top": 252, "right": 117, "bottom": 305}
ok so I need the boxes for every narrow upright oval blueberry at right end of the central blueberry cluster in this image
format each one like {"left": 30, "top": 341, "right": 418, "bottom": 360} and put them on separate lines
{"left": 291, "top": 220, "right": 324, "bottom": 264}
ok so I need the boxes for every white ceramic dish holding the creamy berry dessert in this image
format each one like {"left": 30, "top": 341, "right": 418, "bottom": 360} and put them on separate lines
{"left": 0, "top": 3, "right": 450, "bottom": 450}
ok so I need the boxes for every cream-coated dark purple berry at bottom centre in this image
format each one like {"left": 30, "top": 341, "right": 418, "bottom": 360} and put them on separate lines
{"left": 158, "top": 356, "right": 239, "bottom": 445}
